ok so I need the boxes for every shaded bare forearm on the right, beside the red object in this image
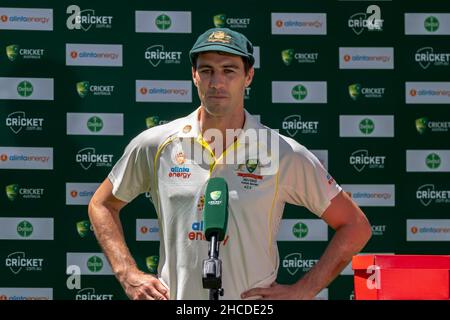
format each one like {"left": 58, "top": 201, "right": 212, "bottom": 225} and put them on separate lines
{"left": 294, "top": 225, "right": 370, "bottom": 299}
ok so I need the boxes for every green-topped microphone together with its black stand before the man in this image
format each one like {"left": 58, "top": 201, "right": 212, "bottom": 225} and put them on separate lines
{"left": 202, "top": 177, "right": 228, "bottom": 300}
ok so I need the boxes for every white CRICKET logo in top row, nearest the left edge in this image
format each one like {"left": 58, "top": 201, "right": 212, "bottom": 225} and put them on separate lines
{"left": 66, "top": 5, "right": 113, "bottom": 31}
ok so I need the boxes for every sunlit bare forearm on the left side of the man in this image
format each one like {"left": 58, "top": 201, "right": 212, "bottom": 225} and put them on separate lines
{"left": 89, "top": 203, "right": 137, "bottom": 280}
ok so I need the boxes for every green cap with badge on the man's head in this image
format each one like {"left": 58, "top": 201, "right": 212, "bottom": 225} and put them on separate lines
{"left": 189, "top": 28, "right": 255, "bottom": 66}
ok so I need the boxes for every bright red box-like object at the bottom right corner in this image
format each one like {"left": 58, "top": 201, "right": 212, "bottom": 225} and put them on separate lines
{"left": 352, "top": 254, "right": 450, "bottom": 300}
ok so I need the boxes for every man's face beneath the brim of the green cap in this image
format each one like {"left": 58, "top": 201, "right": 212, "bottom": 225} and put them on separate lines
{"left": 192, "top": 52, "right": 254, "bottom": 116}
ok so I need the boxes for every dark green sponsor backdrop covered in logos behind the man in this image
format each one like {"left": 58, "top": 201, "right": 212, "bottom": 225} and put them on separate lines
{"left": 0, "top": 0, "right": 450, "bottom": 300}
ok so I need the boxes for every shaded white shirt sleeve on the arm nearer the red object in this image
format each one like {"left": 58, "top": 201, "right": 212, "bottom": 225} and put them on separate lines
{"left": 280, "top": 143, "right": 342, "bottom": 217}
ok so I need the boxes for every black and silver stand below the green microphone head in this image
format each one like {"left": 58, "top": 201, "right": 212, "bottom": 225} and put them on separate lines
{"left": 202, "top": 233, "right": 223, "bottom": 300}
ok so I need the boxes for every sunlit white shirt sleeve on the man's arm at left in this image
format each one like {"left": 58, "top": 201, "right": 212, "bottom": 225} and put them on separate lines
{"left": 108, "top": 134, "right": 153, "bottom": 202}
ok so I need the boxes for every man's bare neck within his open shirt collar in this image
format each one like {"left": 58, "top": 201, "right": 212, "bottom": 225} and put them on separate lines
{"left": 198, "top": 106, "right": 245, "bottom": 154}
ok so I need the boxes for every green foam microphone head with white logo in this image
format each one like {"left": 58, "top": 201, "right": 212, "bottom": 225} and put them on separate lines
{"left": 203, "top": 177, "right": 228, "bottom": 241}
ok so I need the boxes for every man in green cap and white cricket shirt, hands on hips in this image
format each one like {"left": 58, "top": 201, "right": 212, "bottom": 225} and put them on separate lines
{"left": 89, "top": 28, "right": 371, "bottom": 299}
